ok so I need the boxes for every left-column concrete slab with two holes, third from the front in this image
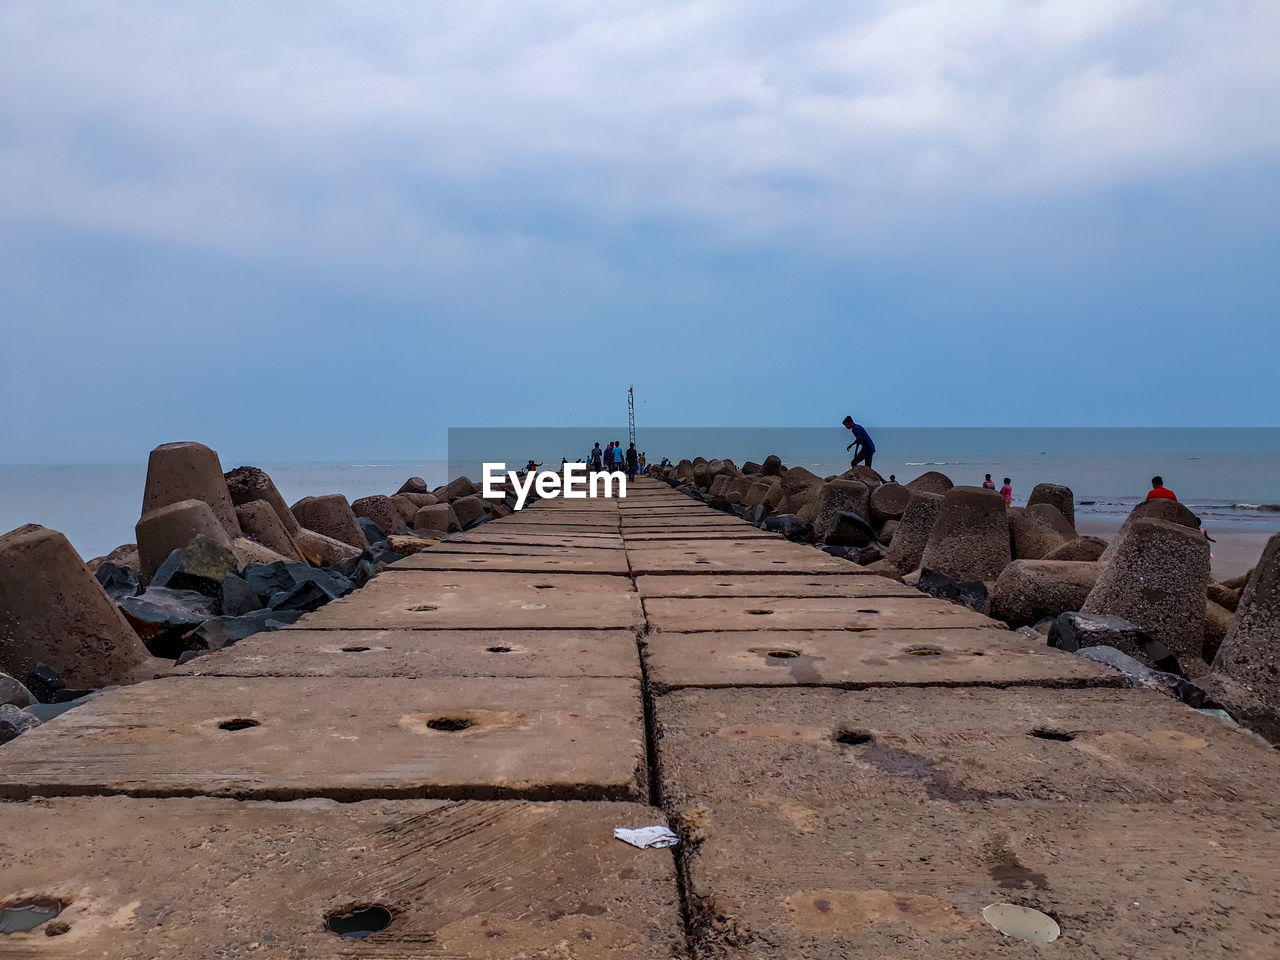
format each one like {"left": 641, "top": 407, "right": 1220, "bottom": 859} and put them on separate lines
{"left": 174, "top": 630, "right": 640, "bottom": 680}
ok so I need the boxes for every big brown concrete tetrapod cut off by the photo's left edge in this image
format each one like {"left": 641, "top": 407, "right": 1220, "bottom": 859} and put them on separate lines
{"left": 0, "top": 524, "right": 160, "bottom": 689}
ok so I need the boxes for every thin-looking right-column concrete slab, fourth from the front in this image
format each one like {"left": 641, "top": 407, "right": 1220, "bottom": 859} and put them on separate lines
{"left": 644, "top": 595, "right": 1004, "bottom": 634}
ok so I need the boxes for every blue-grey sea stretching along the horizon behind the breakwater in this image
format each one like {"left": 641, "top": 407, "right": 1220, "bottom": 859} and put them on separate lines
{"left": 0, "top": 424, "right": 1280, "bottom": 559}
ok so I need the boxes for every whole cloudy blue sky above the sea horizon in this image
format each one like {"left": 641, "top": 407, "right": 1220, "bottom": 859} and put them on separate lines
{"left": 0, "top": 0, "right": 1280, "bottom": 462}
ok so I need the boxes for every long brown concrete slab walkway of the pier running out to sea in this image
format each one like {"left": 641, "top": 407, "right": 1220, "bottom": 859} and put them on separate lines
{"left": 0, "top": 479, "right": 1280, "bottom": 960}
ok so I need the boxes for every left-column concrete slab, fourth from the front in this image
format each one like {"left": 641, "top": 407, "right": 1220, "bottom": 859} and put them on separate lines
{"left": 294, "top": 571, "right": 644, "bottom": 630}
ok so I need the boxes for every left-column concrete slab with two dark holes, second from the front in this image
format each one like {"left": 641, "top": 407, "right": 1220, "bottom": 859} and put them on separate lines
{"left": 0, "top": 677, "right": 646, "bottom": 800}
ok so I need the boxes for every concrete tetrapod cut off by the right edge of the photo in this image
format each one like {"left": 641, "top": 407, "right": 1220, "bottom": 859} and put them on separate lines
{"left": 1202, "top": 534, "right": 1280, "bottom": 742}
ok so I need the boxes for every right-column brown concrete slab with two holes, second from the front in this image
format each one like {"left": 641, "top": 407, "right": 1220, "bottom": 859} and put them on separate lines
{"left": 654, "top": 686, "right": 1280, "bottom": 808}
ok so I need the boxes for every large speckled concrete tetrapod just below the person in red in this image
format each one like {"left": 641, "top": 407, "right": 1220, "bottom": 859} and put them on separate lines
{"left": 1080, "top": 518, "right": 1208, "bottom": 677}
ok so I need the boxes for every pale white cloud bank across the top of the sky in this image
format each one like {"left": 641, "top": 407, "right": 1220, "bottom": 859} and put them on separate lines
{"left": 0, "top": 0, "right": 1280, "bottom": 284}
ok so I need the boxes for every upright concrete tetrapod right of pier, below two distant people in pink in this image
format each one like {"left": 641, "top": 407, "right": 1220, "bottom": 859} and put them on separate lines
{"left": 921, "top": 486, "right": 1012, "bottom": 582}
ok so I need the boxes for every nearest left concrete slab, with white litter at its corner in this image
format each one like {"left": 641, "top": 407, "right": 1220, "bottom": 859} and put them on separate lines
{"left": 0, "top": 797, "right": 684, "bottom": 960}
